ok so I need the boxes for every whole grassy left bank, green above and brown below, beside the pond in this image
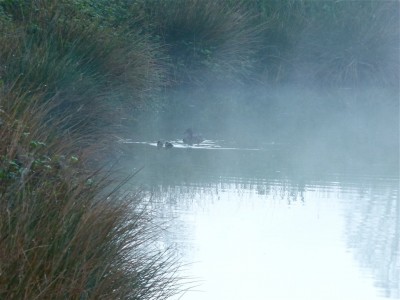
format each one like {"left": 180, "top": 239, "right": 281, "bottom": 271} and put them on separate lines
{"left": 0, "top": 0, "right": 179, "bottom": 299}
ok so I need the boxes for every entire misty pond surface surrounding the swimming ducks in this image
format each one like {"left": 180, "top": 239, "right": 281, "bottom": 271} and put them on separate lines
{"left": 120, "top": 86, "right": 400, "bottom": 300}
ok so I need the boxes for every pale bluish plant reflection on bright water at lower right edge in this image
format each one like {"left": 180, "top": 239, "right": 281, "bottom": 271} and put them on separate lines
{"left": 346, "top": 186, "right": 400, "bottom": 298}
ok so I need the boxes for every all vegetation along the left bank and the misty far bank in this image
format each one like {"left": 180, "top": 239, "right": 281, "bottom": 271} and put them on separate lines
{"left": 0, "top": 0, "right": 399, "bottom": 299}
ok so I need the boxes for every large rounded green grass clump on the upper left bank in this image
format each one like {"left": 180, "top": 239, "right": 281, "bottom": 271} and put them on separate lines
{"left": 0, "top": 0, "right": 164, "bottom": 138}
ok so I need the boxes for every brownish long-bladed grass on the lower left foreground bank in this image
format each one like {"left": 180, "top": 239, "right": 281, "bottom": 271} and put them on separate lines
{"left": 0, "top": 98, "right": 178, "bottom": 299}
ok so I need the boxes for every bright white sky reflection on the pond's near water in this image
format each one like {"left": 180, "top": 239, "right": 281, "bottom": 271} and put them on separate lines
{"left": 171, "top": 187, "right": 383, "bottom": 300}
